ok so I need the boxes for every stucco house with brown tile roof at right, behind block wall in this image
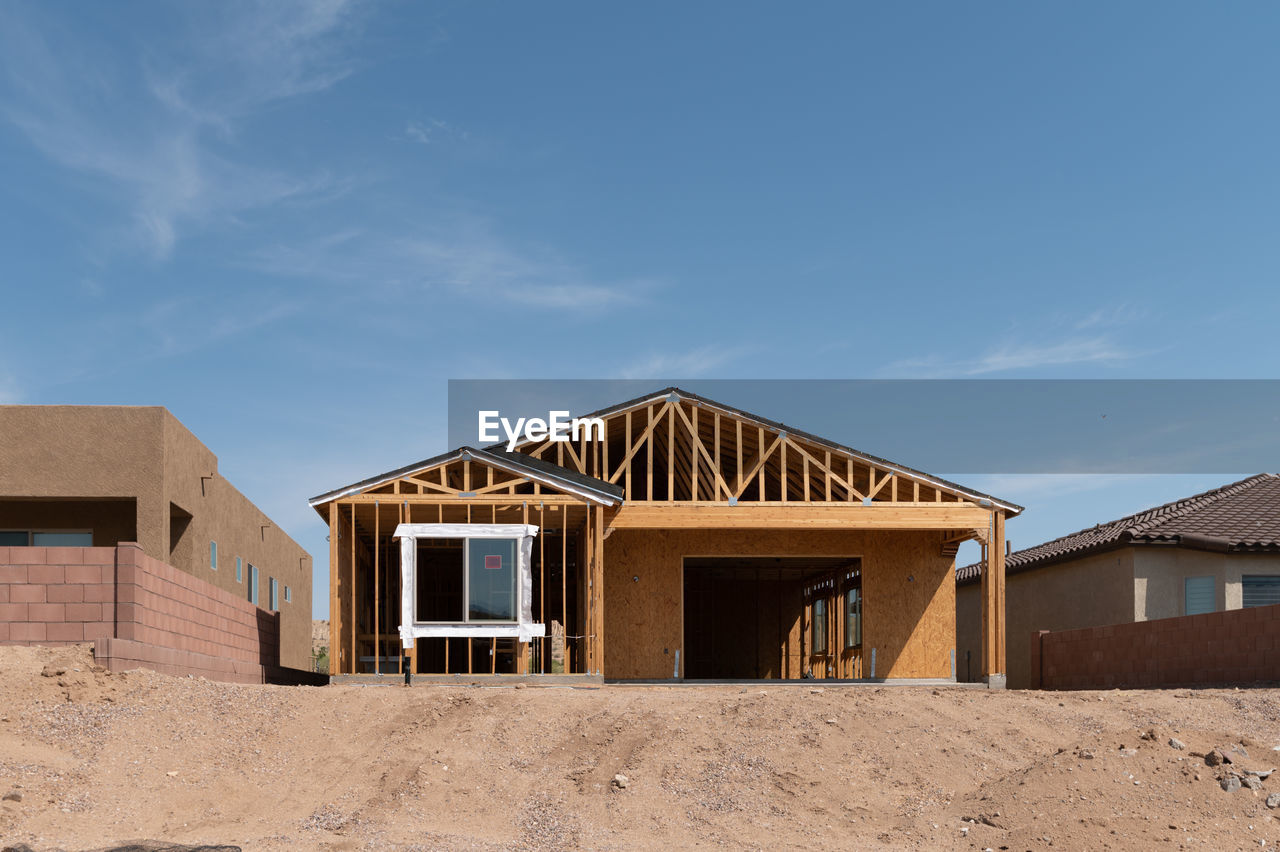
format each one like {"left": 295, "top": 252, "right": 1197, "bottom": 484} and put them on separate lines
{"left": 956, "top": 473, "right": 1280, "bottom": 687}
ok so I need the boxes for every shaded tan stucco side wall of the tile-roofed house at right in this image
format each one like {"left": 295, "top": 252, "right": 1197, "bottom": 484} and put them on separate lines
{"left": 956, "top": 548, "right": 1134, "bottom": 688}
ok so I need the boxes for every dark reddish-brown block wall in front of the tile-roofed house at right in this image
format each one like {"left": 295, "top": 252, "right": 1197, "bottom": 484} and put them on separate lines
{"left": 1030, "top": 605, "right": 1280, "bottom": 690}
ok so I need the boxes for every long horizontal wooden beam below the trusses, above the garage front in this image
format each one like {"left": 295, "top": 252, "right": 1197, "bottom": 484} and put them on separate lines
{"left": 609, "top": 501, "right": 989, "bottom": 530}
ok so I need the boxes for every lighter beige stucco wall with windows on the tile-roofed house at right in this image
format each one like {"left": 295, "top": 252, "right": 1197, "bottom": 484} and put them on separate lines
{"left": 1133, "top": 546, "right": 1280, "bottom": 622}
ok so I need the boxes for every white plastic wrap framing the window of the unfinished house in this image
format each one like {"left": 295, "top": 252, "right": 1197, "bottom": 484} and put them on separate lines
{"left": 393, "top": 523, "right": 547, "bottom": 647}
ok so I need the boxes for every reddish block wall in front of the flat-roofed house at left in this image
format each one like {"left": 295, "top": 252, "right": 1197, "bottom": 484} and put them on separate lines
{"left": 0, "top": 544, "right": 294, "bottom": 682}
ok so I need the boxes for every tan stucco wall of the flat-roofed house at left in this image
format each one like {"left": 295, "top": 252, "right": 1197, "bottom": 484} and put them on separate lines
{"left": 0, "top": 406, "right": 311, "bottom": 668}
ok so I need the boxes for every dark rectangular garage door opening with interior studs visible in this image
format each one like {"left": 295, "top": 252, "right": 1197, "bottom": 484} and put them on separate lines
{"left": 682, "top": 556, "right": 863, "bottom": 681}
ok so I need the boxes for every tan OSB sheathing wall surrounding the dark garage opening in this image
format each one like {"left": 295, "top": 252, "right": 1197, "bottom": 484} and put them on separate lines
{"left": 604, "top": 530, "right": 955, "bottom": 678}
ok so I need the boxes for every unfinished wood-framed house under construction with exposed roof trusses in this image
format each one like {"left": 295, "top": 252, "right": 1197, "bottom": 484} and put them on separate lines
{"left": 311, "top": 388, "right": 1021, "bottom": 686}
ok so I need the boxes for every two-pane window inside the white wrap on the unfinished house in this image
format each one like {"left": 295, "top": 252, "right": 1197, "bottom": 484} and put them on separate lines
{"left": 415, "top": 539, "right": 517, "bottom": 624}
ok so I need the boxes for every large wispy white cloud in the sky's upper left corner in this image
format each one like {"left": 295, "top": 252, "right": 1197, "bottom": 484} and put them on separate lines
{"left": 0, "top": 0, "right": 360, "bottom": 257}
